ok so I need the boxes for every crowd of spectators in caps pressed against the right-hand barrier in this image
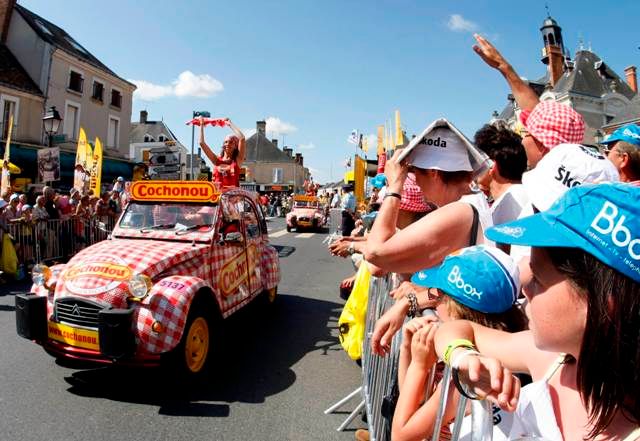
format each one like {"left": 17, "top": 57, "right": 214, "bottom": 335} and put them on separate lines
{"left": 330, "top": 36, "right": 640, "bottom": 440}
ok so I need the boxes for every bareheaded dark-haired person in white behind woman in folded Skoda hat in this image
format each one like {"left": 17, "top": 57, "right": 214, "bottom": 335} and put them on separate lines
{"left": 474, "top": 124, "right": 529, "bottom": 224}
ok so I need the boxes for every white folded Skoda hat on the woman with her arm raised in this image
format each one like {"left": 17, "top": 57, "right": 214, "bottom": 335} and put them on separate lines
{"left": 398, "top": 118, "right": 489, "bottom": 176}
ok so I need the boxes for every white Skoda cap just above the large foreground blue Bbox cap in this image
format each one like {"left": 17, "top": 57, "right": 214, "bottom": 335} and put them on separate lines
{"left": 522, "top": 144, "right": 620, "bottom": 211}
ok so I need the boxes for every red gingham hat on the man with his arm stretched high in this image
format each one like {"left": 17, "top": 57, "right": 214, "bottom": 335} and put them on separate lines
{"left": 520, "top": 101, "right": 584, "bottom": 150}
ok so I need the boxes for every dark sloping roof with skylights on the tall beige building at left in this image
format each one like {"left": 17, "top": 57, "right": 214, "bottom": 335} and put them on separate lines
{"left": 15, "top": 4, "right": 133, "bottom": 85}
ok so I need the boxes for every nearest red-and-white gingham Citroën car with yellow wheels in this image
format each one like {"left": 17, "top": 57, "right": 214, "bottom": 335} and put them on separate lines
{"left": 16, "top": 181, "right": 280, "bottom": 374}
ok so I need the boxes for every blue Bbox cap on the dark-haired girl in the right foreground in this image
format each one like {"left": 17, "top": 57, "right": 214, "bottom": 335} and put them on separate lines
{"left": 486, "top": 182, "right": 640, "bottom": 282}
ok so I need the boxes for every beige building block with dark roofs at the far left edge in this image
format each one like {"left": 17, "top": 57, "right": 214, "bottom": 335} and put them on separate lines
{"left": 0, "top": 0, "right": 136, "bottom": 187}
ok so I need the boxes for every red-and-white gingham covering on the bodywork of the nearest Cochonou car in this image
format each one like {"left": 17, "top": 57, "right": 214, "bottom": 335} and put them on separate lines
{"left": 47, "top": 227, "right": 280, "bottom": 354}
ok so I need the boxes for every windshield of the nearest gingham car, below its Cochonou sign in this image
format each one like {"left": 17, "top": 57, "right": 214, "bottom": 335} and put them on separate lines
{"left": 118, "top": 202, "right": 216, "bottom": 232}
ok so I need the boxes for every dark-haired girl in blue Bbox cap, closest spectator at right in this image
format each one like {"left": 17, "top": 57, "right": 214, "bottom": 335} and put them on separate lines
{"left": 435, "top": 183, "right": 640, "bottom": 440}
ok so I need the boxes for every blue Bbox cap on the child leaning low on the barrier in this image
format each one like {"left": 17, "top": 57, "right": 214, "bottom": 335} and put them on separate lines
{"left": 411, "top": 245, "right": 520, "bottom": 314}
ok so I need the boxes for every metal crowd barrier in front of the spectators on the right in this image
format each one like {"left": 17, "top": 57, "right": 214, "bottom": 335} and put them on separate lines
{"left": 325, "top": 274, "right": 493, "bottom": 441}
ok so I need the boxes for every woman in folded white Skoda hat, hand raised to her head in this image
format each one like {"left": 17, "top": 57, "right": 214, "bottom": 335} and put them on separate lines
{"left": 364, "top": 123, "right": 493, "bottom": 355}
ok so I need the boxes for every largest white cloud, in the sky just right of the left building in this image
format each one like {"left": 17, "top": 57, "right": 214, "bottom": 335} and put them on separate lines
{"left": 129, "top": 70, "right": 224, "bottom": 101}
